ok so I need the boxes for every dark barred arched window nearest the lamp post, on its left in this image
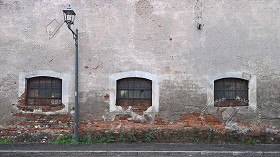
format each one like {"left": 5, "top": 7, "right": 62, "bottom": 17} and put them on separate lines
{"left": 27, "top": 77, "right": 62, "bottom": 106}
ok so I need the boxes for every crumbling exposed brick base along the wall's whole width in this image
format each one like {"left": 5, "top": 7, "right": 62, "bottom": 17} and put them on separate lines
{"left": 0, "top": 113, "right": 280, "bottom": 143}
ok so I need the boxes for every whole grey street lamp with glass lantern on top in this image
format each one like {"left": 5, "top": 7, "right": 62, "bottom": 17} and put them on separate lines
{"left": 62, "top": 5, "right": 79, "bottom": 143}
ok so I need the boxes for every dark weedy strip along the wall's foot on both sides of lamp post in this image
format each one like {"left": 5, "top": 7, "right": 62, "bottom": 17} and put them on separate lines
{"left": 0, "top": 128, "right": 280, "bottom": 145}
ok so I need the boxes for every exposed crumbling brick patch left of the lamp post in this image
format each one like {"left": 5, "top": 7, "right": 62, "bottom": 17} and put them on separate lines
{"left": 0, "top": 113, "right": 73, "bottom": 142}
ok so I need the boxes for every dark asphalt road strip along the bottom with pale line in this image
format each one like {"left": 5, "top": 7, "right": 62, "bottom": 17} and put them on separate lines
{"left": 0, "top": 143, "right": 280, "bottom": 157}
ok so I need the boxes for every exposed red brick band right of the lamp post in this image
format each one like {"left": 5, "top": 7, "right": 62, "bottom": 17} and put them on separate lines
{"left": 79, "top": 113, "right": 221, "bottom": 133}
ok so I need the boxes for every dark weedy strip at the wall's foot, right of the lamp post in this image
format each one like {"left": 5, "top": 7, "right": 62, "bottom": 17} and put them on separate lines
{"left": 80, "top": 128, "right": 280, "bottom": 144}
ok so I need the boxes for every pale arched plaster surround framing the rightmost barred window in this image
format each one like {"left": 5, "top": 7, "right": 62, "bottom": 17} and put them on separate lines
{"left": 207, "top": 71, "right": 257, "bottom": 113}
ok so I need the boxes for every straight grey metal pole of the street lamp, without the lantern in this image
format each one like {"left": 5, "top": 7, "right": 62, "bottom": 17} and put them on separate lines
{"left": 74, "top": 29, "right": 79, "bottom": 144}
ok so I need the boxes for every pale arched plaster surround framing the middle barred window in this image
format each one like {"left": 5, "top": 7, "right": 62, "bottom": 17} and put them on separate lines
{"left": 109, "top": 71, "right": 159, "bottom": 113}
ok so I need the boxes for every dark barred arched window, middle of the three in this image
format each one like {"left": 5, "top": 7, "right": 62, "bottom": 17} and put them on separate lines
{"left": 116, "top": 77, "right": 152, "bottom": 106}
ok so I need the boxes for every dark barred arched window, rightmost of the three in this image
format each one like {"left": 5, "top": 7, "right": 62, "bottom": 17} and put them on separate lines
{"left": 214, "top": 78, "right": 249, "bottom": 107}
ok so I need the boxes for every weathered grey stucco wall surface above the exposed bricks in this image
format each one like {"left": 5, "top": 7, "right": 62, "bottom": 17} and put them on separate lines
{"left": 0, "top": 0, "right": 280, "bottom": 139}
